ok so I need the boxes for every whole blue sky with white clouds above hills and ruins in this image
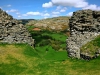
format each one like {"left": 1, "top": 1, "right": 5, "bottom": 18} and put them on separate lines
{"left": 0, "top": 0, "right": 100, "bottom": 19}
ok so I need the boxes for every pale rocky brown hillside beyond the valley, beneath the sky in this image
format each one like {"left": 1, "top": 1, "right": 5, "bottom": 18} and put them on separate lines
{"left": 26, "top": 16, "right": 70, "bottom": 31}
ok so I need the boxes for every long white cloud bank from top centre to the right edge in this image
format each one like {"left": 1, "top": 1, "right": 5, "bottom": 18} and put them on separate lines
{"left": 42, "top": 0, "right": 100, "bottom": 12}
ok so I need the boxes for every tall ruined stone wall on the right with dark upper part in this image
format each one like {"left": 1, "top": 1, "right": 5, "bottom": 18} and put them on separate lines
{"left": 67, "top": 10, "right": 100, "bottom": 59}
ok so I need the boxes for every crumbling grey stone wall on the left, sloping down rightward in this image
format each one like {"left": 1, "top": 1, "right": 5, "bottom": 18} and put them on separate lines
{"left": 0, "top": 9, "right": 34, "bottom": 46}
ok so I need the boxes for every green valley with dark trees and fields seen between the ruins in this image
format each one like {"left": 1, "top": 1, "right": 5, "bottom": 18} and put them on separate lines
{"left": 30, "top": 30, "right": 67, "bottom": 51}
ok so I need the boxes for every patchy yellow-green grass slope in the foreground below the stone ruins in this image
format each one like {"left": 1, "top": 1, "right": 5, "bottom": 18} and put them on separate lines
{"left": 0, "top": 44, "right": 100, "bottom": 75}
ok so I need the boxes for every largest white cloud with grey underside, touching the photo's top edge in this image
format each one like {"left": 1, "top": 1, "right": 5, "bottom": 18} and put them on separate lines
{"left": 42, "top": 0, "right": 88, "bottom": 8}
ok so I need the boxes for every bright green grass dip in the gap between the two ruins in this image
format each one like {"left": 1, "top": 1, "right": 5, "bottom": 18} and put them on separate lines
{"left": 36, "top": 46, "right": 67, "bottom": 61}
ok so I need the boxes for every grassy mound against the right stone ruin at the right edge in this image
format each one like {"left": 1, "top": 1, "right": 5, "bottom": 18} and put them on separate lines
{"left": 80, "top": 35, "right": 100, "bottom": 56}
